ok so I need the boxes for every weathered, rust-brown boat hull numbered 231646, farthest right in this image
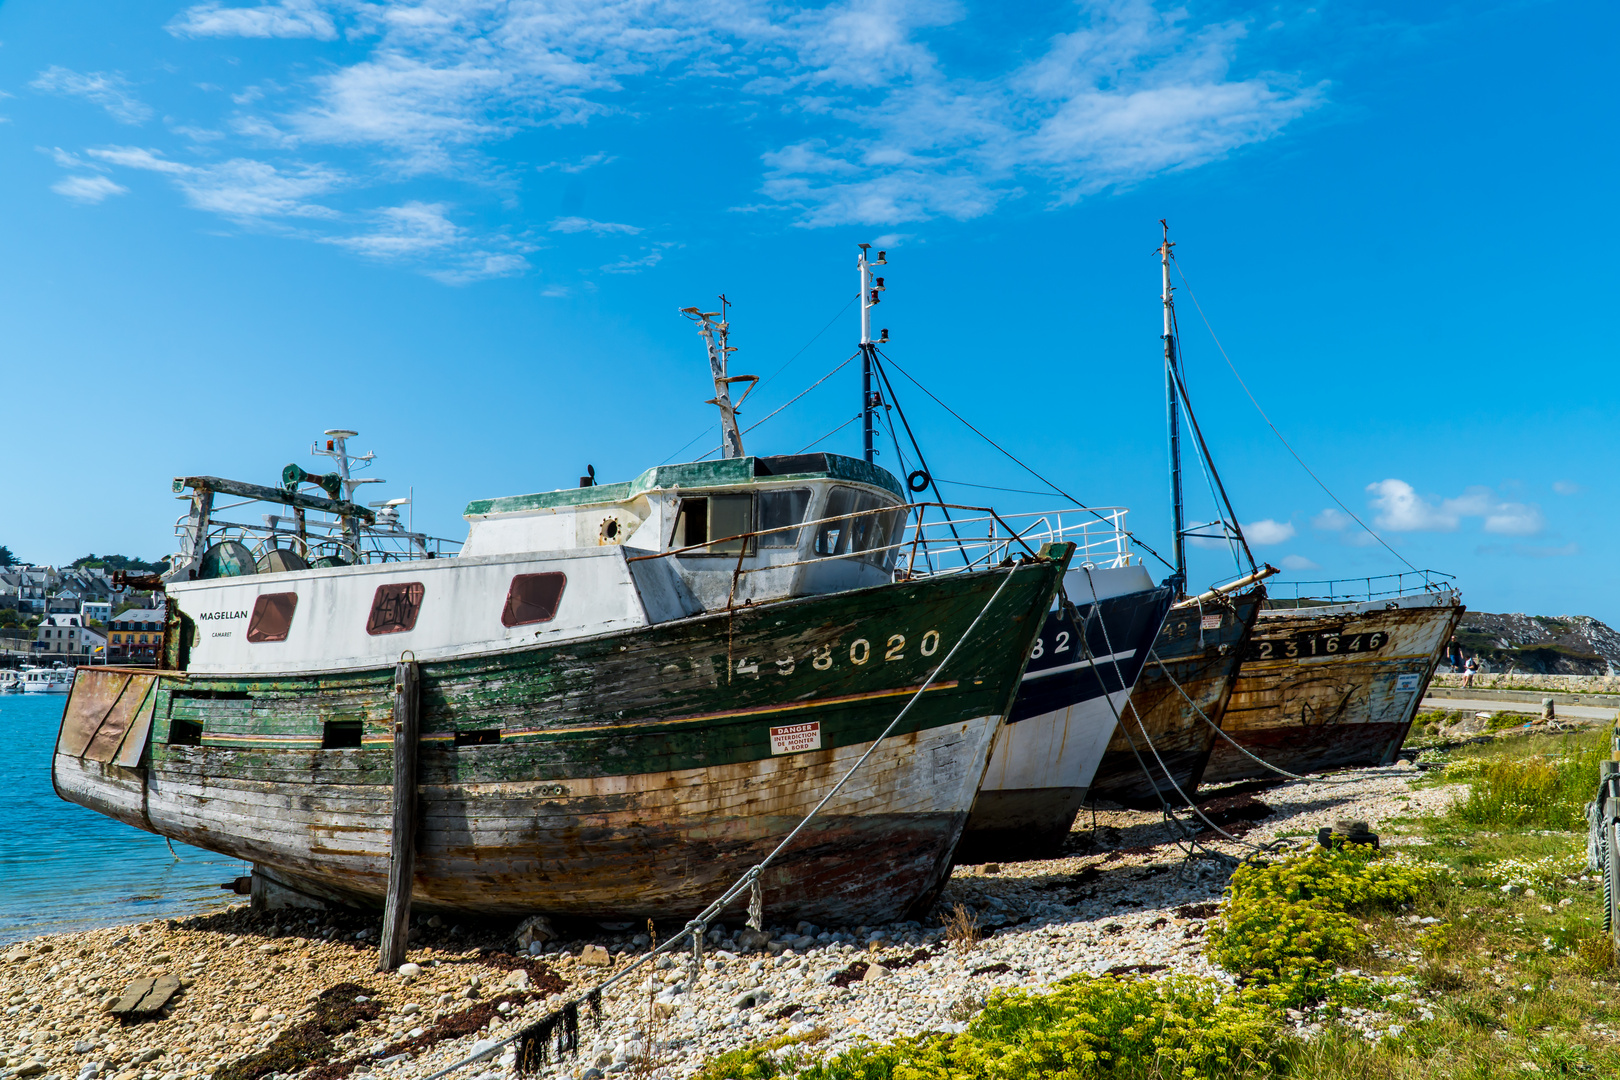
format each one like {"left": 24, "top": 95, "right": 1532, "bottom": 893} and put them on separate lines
{"left": 1202, "top": 593, "right": 1463, "bottom": 784}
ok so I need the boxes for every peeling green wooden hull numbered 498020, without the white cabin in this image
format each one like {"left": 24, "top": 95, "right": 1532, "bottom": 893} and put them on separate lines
{"left": 53, "top": 559, "right": 1061, "bottom": 925}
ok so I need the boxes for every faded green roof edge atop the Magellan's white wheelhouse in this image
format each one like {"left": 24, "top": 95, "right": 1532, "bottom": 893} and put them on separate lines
{"left": 462, "top": 453, "right": 906, "bottom": 518}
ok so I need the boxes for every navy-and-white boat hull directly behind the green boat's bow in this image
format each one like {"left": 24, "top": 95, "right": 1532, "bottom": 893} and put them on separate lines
{"left": 956, "top": 567, "right": 1171, "bottom": 863}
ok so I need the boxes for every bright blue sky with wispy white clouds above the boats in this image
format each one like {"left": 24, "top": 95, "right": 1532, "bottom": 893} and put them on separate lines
{"left": 0, "top": 0, "right": 1620, "bottom": 622}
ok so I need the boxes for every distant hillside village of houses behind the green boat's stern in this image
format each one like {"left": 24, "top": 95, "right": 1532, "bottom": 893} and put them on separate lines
{"left": 0, "top": 547, "right": 165, "bottom": 667}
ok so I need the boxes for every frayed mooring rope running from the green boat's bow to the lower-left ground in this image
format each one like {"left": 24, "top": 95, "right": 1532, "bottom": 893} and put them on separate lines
{"left": 426, "top": 563, "right": 1023, "bottom": 1080}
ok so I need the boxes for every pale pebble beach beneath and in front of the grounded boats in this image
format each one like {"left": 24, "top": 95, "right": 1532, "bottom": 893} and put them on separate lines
{"left": 0, "top": 769, "right": 1452, "bottom": 1080}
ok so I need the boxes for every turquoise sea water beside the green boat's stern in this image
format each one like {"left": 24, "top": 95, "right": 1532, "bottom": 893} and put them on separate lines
{"left": 0, "top": 693, "right": 248, "bottom": 942}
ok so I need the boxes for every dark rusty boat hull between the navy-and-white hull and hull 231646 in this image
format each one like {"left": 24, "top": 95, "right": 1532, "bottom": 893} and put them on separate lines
{"left": 1090, "top": 586, "right": 1265, "bottom": 808}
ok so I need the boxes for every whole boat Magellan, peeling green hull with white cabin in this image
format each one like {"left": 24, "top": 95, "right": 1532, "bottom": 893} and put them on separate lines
{"left": 53, "top": 313, "right": 1072, "bottom": 923}
